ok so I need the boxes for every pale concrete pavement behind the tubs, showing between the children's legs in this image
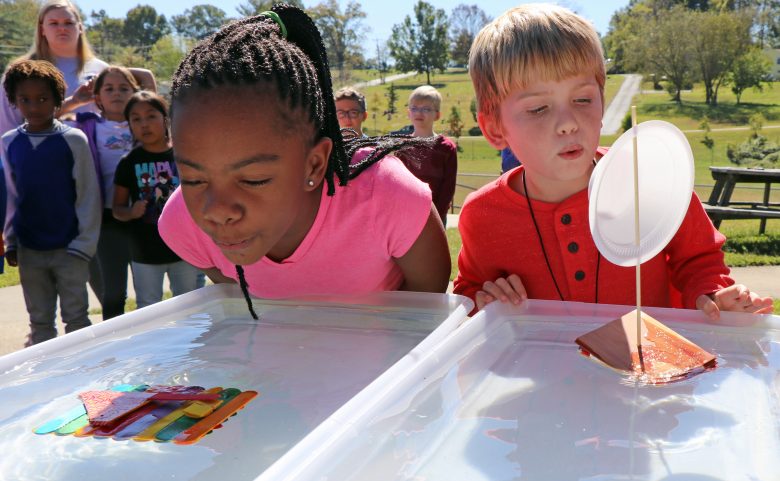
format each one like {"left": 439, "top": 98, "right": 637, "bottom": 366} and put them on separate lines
{"left": 0, "top": 258, "right": 780, "bottom": 356}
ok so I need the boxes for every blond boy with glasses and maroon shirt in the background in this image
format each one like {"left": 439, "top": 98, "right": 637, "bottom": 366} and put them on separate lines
{"left": 396, "top": 85, "right": 458, "bottom": 226}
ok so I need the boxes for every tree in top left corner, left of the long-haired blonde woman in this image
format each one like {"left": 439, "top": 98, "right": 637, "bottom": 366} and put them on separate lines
{"left": 0, "top": 0, "right": 39, "bottom": 70}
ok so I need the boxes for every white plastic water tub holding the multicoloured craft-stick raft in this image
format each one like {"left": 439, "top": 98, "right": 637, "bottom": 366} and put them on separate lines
{"left": 0, "top": 285, "right": 472, "bottom": 481}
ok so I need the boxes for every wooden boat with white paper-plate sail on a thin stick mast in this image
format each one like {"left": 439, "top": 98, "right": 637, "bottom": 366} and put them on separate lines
{"left": 576, "top": 116, "right": 715, "bottom": 384}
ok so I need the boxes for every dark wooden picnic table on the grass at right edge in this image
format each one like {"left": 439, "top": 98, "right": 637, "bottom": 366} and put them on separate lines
{"left": 704, "top": 166, "right": 780, "bottom": 234}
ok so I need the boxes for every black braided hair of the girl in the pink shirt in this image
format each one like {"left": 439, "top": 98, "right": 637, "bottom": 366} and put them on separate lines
{"left": 171, "top": 4, "right": 433, "bottom": 318}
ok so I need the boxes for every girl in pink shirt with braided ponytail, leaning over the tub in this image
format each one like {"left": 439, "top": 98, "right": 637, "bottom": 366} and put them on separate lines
{"left": 160, "top": 5, "right": 450, "bottom": 316}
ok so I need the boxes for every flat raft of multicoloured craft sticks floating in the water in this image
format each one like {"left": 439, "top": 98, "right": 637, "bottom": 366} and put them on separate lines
{"left": 34, "top": 385, "right": 257, "bottom": 444}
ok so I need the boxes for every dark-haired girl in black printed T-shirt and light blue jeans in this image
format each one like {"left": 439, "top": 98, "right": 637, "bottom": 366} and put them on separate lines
{"left": 113, "top": 91, "right": 198, "bottom": 308}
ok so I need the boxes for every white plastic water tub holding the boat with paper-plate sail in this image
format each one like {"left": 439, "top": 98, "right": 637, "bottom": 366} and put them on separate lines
{"left": 272, "top": 301, "right": 780, "bottom": 481}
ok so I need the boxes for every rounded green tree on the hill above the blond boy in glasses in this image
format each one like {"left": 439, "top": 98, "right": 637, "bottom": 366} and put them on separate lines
{"left": 388, "top": 0, "right": 448, "bottom": 84}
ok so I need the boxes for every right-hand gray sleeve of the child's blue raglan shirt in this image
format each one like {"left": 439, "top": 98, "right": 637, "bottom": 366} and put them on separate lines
{"left": 63, "top": 129, "right": 102, "bottom": 260}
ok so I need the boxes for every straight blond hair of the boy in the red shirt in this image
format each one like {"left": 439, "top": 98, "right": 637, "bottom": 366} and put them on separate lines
{"left": 469, "top": 4, "right": 606, "bottom": 120}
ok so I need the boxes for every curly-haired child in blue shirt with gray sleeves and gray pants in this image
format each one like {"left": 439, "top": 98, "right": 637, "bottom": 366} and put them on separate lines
{"left": 1, "top": 60, "right": 100, "bottom": 344}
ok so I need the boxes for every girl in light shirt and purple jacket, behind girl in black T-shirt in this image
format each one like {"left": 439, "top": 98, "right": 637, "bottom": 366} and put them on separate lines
{"left": 71, "top": 65, "right": 140, "bottom": 320}
